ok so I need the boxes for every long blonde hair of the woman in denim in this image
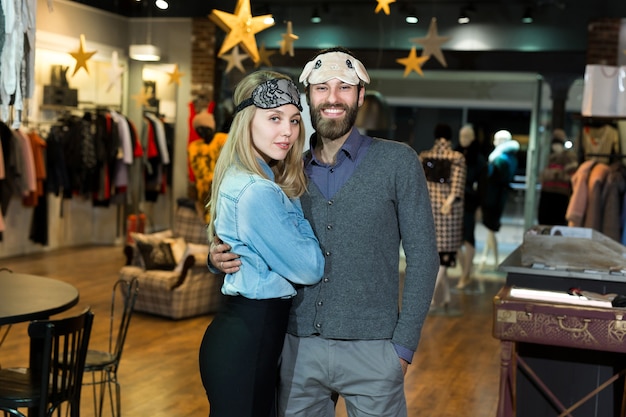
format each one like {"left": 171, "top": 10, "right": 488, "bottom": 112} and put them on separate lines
{"left": 207, "top": 70, "right": 307, "bottom": 242}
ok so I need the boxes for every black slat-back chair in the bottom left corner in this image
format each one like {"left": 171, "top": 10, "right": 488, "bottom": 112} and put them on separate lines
{"left": 0, "top": 308, "right": 93, "bottom": 417}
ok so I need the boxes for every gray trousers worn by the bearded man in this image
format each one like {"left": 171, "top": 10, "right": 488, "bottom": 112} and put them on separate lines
{"left": 278, "top": 334, "right": 407, "bottom": 417}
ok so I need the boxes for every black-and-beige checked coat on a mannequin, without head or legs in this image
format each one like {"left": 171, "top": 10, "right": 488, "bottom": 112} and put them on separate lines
{"left": 420, "top": 139, "right": 467, "bottom": 253}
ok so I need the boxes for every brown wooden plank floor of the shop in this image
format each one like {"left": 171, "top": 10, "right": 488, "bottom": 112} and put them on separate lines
{"left": 0, "top": 246, "right": 503, "bottom": 417}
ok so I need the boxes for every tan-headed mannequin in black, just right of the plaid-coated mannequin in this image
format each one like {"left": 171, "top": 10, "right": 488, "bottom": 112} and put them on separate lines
{"left": 455, "top": 125, "right": 487, "bottom": 289}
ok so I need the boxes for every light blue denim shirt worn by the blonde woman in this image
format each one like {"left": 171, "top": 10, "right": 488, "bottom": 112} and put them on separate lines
{"left": 215, "top": 161, "right": 324, "bottom": 299}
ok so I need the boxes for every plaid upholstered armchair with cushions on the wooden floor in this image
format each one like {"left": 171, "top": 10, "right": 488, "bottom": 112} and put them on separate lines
{"left": 120, "top": 199, "right": 223, "bottom": 319}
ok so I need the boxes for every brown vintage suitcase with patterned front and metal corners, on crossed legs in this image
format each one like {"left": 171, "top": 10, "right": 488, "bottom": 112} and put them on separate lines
{"left": 493, "top": 287, "right": 626, "bottom": 352}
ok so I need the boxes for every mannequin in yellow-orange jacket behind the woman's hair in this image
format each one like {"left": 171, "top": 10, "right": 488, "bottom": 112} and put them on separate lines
{"left": 187, "top": 103, "right": 228, "bottom": 222}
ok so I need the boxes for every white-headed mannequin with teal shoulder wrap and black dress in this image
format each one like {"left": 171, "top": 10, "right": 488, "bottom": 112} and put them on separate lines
{"left": 480, "top": 130, "right": 520, "bottom": 269}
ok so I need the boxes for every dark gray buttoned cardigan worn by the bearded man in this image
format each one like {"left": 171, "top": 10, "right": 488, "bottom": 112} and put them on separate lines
{"left": 288, "top": 139, "right": 439, "bottom": 351}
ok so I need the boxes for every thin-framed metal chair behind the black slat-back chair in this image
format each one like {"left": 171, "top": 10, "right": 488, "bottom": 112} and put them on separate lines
{"left": 83, "top": 278, "right": 139, "bottom": 417}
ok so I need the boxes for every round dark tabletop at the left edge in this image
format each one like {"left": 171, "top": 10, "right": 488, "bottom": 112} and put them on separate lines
{"left": 0, "top": 271, "right": 78, "bottom": 325}
